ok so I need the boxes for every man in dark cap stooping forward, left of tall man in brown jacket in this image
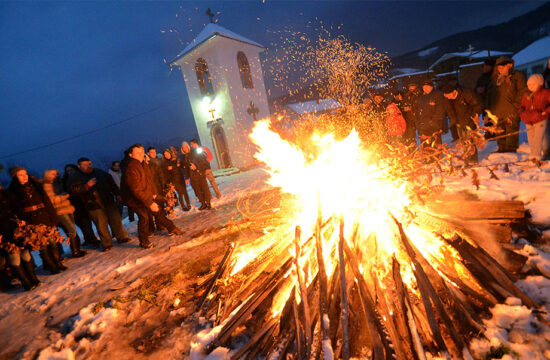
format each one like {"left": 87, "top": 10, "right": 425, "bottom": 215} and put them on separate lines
{"left": 443, "top": 84, "right": 483, "bottom": 162}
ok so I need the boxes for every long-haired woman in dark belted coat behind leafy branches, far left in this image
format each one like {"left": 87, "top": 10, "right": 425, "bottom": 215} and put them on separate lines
{"left": 9, "top": 166, "right": 67, "bottom": 274}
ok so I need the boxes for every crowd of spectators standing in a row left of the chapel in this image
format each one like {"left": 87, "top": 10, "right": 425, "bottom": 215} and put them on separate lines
{"left": 0, "top": 139, "right": 221, "bottom": 290}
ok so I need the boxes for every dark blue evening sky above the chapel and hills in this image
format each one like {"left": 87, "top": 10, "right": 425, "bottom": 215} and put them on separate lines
{"left": 0, "top": 0, "right": 541, "bottom": 180}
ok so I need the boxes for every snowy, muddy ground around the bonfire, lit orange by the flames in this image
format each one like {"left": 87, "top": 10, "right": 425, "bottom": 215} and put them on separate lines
{"left": 0, "top": 139, "right": 550, "bottom": 359}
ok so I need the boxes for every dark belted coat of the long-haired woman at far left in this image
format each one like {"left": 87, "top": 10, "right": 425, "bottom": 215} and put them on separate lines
{"left": 9, "top": 177, "right": 59, "bottom": 226}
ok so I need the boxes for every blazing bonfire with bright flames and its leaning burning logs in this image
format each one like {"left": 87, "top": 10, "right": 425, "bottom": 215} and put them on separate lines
{"left": 191, "top": 121, "right": 537, "bottom": 359}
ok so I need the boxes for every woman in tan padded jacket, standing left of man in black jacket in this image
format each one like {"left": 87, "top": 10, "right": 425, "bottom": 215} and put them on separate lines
{"left": 42, "top": 169, "right": 86, "bottom": 258}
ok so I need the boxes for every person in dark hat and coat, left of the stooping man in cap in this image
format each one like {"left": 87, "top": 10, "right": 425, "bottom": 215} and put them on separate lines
{"left": 415, "top": 80, "right": 445, "bottom": 144}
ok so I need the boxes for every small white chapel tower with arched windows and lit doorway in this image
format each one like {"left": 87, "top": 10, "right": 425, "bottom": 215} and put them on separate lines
{"left": 171, "top": 23, "right": 269, "bottom": 170}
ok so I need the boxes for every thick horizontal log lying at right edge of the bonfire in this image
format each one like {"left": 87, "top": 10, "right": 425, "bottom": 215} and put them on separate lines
{"left": 426, "top": 200, "right": 525, "bottom": 219}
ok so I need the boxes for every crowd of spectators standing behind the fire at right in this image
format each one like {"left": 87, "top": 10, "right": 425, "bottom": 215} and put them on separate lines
{"left": 365, "top": 57, "right": 550, "bottom": 162}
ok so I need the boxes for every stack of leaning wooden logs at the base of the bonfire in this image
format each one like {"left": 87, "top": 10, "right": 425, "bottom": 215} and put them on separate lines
{"left": 197, "top": 201, "right": 538, "bottom": 360}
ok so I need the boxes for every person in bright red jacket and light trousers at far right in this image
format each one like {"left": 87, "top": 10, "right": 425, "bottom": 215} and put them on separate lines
{"left": 518, "top": 74, "right": 550, "bottom": 160}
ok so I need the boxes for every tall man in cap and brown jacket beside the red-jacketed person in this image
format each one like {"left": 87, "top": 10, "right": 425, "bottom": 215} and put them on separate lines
{"left": 486, "top": 57, "right": 526, "bottom": 152}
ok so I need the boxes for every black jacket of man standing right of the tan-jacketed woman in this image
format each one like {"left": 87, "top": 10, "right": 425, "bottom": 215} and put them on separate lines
{"left": 67, "top": 169, "right": 120, "bottom": 210}
